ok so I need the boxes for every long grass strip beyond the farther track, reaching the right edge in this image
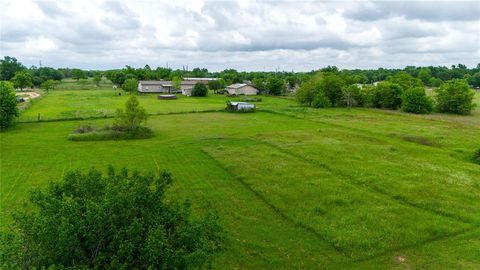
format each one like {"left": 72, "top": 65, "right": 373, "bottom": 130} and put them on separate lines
{"left": 259, "top": 127, "right": 480, "bottom": 225}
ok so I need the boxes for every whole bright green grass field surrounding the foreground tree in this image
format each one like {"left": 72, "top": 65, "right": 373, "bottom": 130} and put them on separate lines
{"left": 0, "top": 84, "right": 480, "bottom": 269}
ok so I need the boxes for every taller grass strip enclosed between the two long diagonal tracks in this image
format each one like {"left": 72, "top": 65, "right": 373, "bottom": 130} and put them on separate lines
{"left": 205, "top": 141, "right": 470, "bottom": 259}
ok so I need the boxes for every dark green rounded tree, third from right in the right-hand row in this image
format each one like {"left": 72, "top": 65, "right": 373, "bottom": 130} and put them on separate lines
{"left": 372, "top": 82, "right": 403, "bottom": 110}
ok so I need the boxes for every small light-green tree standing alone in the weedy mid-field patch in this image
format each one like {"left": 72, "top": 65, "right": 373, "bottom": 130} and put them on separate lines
{"left": 116, "top": 95, "right": 148, "bottom": 130}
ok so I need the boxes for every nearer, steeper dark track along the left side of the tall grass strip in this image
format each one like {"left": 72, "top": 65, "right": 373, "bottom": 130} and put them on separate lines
{"left": 201, "top": 149, "right": 349, "bottom": 258}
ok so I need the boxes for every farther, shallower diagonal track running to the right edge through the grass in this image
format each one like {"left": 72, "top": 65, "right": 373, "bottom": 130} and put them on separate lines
{"left": 258, "top": 139, "right": 474, "bottom": 225}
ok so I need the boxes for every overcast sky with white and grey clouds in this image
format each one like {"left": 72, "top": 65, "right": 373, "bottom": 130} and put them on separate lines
{"left": 0, "top": 0, "right": 480, "bottom": 71}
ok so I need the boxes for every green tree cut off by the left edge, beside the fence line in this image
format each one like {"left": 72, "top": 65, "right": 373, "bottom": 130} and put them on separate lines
{"left": 0, "top": 81, "right": 18, "bottom": 131}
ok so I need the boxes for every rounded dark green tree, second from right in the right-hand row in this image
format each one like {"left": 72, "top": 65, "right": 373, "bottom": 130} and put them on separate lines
{"left": 402, "top": 87, "right": 433, "bottom": 114}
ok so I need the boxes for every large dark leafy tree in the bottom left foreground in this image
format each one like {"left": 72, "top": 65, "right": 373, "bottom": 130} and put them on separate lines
{"left": 2, "top": 168, "right": 223, "bottom": 269}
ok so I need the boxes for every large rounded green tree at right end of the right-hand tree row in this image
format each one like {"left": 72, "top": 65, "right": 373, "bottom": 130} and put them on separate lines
{"left": 435, "top": 79, "right": 475, "bottom": 115}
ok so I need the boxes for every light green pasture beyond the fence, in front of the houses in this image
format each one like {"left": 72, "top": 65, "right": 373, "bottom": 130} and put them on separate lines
{"left": 19, "top": 88, "right": 296, "bottom": 122}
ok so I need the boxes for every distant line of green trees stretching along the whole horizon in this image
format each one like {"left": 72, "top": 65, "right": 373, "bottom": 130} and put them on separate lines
{"left": 0, "top": 56, "right": 480, "bottom": 88}
